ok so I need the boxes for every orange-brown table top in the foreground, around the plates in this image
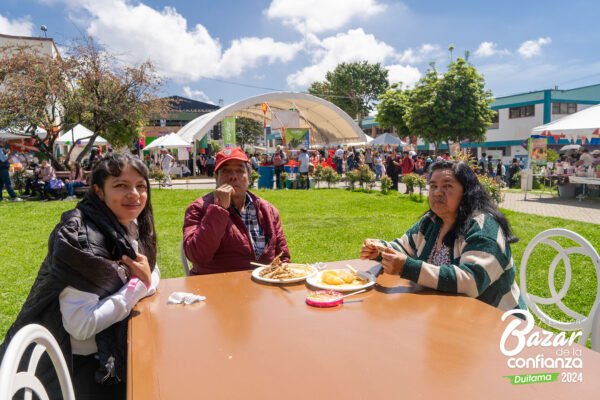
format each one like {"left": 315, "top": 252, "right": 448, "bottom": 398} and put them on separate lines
{"left": 127, "top": 260, "right": 600, "bottom": 400}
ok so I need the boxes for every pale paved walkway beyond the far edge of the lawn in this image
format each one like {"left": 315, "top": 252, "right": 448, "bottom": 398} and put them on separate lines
{"left": 152, "top": 178, "right": 600, "bottom": 224}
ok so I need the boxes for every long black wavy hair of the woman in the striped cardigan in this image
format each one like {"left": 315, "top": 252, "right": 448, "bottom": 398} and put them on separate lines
{"left": 428, "top": 160, "right": 519, "bottom": 243}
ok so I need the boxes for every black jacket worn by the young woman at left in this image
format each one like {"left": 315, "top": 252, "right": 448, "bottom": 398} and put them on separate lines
{"left": 0, "top": 192, "right": 136, "bottom": 398}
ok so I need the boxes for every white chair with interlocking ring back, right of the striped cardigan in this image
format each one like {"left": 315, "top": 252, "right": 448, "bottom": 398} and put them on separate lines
{"left": 520, "top": 228, "right": 600, "bottom": 351}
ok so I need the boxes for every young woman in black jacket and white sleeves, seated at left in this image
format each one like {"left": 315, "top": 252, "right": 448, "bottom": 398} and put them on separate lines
{"left": 0, "top": 153, "right": 160, "bottom": 399}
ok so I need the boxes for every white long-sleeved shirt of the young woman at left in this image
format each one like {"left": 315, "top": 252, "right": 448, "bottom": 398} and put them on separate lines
{"left": 59, "top": 266, "right": 160, "bottom": 355}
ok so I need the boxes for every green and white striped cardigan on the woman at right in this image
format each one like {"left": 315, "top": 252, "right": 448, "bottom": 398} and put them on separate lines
{"left": 382, "top": 214, "right": 526, "bottom": 310}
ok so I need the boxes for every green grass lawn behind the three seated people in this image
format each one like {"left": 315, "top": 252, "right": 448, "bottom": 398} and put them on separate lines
{"left": 0, "top": 189, "right": 600, "bottom": 338}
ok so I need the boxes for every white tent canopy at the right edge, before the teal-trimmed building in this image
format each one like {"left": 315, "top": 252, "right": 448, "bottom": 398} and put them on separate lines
{"left": 531, "top": 104, "right": 600, "bottom": 138}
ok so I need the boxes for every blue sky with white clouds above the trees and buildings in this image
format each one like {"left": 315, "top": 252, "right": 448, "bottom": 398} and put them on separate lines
{"left": 0, "top": 0, "right": 600, "bottom": 105}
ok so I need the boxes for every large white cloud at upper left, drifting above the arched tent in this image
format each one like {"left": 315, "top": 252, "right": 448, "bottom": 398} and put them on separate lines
{"left": 56, "top": 0, "right": 302, "bottom": 81}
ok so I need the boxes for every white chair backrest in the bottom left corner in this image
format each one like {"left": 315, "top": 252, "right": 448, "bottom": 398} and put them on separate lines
{"left": 0, "top": 324, "right": 75, "bottom": 400}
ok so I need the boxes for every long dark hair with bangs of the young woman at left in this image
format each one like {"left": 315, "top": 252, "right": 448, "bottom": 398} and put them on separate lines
{"left": 90, "top": 152, "right": 156, "bottom": 268}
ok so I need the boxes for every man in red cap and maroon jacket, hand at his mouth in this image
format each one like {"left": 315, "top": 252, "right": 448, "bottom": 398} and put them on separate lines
{"left": 183, "top": 148, "right": 290, "bottom": 275}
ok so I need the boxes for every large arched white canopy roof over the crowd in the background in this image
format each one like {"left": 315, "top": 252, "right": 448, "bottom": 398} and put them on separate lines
{"left": 177, "top": 92, "right": 366, "bottom": 144}
